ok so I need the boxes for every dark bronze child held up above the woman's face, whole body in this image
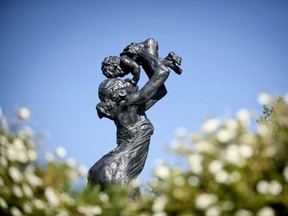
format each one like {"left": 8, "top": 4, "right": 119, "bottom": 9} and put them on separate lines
{"left": 101, "top": 38, "right": 182, "bottom": 85}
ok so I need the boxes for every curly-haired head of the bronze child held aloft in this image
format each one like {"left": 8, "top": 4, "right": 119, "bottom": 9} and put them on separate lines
{"left": 101, "top": 56, "right": 126, "bottom": 78}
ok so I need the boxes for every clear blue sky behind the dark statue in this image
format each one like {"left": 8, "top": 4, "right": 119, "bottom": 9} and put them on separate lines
{"left": 0, "top": 0, "right": 288, "bottom": 186}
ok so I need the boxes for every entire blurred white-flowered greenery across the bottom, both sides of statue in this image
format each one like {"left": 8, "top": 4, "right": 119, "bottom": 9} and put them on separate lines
{"left": 0, "top": 93, "right": 288, "bottom": 216}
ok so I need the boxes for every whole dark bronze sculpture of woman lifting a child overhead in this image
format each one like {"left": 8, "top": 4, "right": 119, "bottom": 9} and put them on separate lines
{"left": 88, "top": 39, "right": 182, "bottom": 197}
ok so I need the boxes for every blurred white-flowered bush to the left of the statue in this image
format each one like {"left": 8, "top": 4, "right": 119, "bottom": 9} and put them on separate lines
{"left": 0, "top": 107, "right": 107, "bottom": 216}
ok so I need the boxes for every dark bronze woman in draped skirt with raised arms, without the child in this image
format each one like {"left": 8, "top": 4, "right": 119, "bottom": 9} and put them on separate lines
{"left": 88, "top": 39, "right": 182, "bottom": 196}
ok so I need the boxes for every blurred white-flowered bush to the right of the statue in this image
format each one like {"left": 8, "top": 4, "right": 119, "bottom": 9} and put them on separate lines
{"left": 150, "top": 93, "right": 288, "bottom": 216}
